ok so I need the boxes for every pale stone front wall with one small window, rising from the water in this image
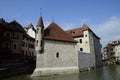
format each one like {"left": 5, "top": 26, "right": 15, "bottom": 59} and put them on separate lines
{"left": 33, "top": 40, "right": 78, "bottom": 76}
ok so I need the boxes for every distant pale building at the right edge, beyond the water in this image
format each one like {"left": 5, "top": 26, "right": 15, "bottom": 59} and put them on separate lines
{"left": 104, "top": 40, "right": 120, "bottom": 63}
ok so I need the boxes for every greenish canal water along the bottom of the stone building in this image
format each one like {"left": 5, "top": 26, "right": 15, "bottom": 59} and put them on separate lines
{"left": 3, "top": 65, "right": 120, "bottom": 80}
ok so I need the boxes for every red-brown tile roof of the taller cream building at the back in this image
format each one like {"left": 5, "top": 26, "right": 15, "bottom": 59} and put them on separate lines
{"left": 66, "top": 24, "right": 100, "bottom": 39}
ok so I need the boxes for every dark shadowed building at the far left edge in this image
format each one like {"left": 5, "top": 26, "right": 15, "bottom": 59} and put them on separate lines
{"left": 0, "top": 19, "right": 24, "bottom": 67}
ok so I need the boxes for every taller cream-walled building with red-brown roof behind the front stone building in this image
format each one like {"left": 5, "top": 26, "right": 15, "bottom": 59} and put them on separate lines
{"left": 66, "top": 24, "right": 102, "bottom": 67}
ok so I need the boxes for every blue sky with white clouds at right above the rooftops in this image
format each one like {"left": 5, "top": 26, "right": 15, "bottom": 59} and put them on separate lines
{"left": 0, "top": 0, "right": 120, "bottom": 46}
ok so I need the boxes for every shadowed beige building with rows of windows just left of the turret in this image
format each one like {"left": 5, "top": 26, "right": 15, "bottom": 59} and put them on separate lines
{"left": 21, "top": 33, "right": 36, "bottom": 63}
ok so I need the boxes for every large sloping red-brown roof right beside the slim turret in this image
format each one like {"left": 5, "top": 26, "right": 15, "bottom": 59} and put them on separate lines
{"left": 44, "top": 22, "right": 77, "bottom": 43}
